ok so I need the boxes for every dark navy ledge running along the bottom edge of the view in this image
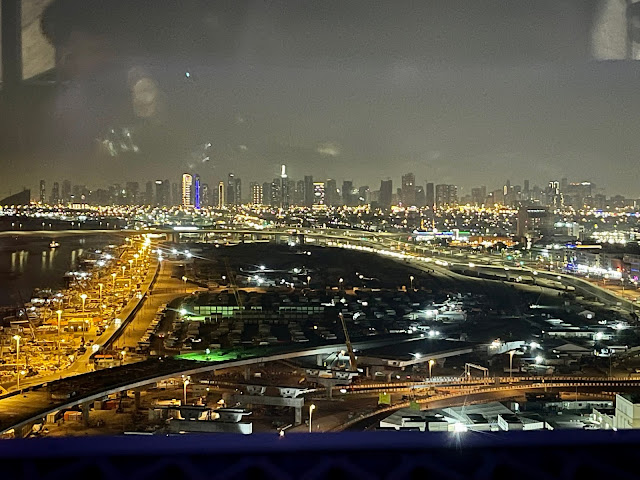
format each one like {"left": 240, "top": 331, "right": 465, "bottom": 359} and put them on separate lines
{"left": 0, "top": 430, "right": 640, "bottom": 480}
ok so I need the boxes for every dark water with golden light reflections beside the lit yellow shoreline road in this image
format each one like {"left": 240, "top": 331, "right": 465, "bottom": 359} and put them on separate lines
{"left": 0, "top": 235, "right": 122, "bottom": 307}
